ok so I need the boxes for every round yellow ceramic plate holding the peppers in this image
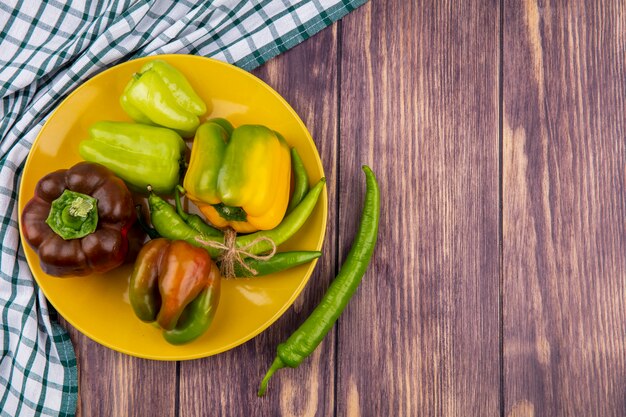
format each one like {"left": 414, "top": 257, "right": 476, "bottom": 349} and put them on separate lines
{"left": 19, "top": 55, "right": 327, "bottom": 360}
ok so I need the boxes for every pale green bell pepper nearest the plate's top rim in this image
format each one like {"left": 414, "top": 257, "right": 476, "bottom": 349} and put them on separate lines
{"left": 120, "top": 59, "right": 207, "bottom": 137}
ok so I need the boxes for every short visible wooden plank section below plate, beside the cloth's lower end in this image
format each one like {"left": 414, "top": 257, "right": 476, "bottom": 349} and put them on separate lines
{"left": 61, "top": 320, "right": 177, "bottom": 417}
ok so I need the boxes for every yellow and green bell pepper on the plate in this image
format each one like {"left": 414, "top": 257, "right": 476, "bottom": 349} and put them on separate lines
{"left": 183, "top": 119, "right": 291, "bottom": 233}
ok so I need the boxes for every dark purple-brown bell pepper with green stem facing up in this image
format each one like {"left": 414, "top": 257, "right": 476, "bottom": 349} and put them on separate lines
{"left": 21, "top": 162, "right": 136, "bottom": 276}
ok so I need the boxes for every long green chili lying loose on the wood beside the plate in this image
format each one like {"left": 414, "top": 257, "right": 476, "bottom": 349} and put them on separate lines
{"left": 258, "top": 165, "right": 380, "bottom": 396}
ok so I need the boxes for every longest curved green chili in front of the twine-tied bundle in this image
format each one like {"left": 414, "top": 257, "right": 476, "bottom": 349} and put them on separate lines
{"left": 148, "top": 178, "right": 326, "bottom": 258}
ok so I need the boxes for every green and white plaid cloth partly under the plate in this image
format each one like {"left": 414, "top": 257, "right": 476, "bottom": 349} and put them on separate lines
{"left": 0, "top": 0, "right": 365, "bottom": 417}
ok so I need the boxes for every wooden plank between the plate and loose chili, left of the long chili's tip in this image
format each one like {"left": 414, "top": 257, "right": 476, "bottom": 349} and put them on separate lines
{"left": 180, "top": 25, "right": 337, "bottom": 417}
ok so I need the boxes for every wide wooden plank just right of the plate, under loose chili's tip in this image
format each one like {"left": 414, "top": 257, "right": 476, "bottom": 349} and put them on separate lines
{"left": 337, "top": 1, "right": 500, "bottom": 416}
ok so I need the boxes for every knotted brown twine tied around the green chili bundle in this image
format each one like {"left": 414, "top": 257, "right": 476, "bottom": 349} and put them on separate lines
{"left": 196, "top": 227, "right": 276, "bottom": 278}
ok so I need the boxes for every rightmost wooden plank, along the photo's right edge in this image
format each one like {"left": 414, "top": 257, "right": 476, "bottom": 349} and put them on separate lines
{"left": 503, "top": 0, "right": 626, "bottom": 417}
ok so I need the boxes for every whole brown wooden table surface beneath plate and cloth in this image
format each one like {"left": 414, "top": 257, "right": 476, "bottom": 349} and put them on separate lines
{"left": 66, "top": 0, "right": 626, "bottom": 417}
